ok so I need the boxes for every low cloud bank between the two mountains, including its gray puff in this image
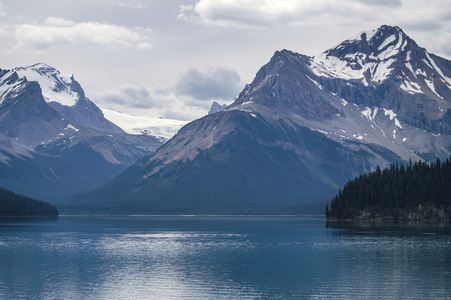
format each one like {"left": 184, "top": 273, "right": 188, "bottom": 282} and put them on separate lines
{"left": 91, "top": 67, "right": 242, "bottom": 121}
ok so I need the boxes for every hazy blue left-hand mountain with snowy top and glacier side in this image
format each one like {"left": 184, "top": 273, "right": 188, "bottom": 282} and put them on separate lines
{"left": 0, "top": 64, "right": 162, "bottom": 203}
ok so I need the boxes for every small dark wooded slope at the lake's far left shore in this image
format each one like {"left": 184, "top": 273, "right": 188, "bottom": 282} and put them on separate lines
{"left": 0, "top": 188, "right": 58, "bottom": 216}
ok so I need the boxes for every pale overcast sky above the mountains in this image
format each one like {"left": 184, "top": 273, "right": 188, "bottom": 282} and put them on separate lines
{"left": 0, "top": 0, "right": 451, "bottom": 121}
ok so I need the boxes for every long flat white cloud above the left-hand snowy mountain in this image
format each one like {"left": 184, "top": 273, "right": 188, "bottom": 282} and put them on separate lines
{"left": 15, "top": 17, "right": 152, "bottom": 50}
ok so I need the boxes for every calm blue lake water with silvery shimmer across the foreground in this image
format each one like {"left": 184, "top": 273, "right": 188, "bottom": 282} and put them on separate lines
{"left": 0, "top": 217, "right": 451, "bottom": 299}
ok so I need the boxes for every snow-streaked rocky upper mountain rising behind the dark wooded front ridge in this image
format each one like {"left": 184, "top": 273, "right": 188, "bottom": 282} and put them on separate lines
{"left": 228, "top": 26, "right": 451, "bottom": 160}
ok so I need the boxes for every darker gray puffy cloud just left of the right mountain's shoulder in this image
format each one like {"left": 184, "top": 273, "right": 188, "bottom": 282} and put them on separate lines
{"left": 174, "top": 67, "right": 242, "bottom": 101}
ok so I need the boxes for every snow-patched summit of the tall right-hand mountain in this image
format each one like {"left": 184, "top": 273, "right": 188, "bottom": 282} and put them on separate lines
{"left": 311, "top": 26, "right": 451, "bottom": 94}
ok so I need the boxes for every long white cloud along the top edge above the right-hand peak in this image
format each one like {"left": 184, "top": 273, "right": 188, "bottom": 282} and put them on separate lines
{"left": 178, "top": 0, "right": 450, "bottom": 29}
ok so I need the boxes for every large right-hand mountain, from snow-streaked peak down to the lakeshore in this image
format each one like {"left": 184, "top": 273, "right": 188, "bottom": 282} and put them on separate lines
{"left": 67, "top": 26, "right": 451, "bottom": 214}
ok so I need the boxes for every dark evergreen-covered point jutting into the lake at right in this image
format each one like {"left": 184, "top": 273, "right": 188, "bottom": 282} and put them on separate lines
{"left": 326, "top": 159, "right": 451, "bottom": 220}
